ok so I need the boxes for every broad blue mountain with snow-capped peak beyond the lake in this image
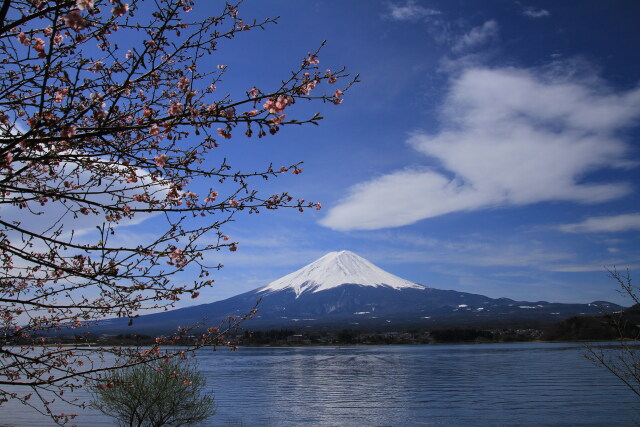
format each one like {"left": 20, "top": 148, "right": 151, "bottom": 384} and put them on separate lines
{"left": 96, "top": 251, "right": 622, "bottom": 333}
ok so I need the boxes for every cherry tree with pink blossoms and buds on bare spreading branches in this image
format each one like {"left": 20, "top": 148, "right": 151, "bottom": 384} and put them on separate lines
{"left": 0, "top": 0, "right": 355, "bottom": 423}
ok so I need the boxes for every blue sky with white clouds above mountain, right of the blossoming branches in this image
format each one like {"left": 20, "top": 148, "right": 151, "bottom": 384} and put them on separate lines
{"left": 135, "top": 0, "right": 640, "bottom": 305}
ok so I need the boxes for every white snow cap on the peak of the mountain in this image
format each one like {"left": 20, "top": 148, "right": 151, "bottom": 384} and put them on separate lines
{"left": 258, "top": 251, "right": 424, "bottom": 296}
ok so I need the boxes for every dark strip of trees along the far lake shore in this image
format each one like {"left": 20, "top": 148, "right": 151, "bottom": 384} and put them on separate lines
{"left": 13, "top": 308, "right": 640, "bottom": 346}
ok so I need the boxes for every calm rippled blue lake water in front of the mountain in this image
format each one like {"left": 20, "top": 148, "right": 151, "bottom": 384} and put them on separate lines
{"left": 0, "top": 343, "right": 640, "bottom": 427}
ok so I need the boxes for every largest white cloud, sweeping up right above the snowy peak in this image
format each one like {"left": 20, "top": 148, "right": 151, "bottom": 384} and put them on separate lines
{"left": 321, "top": 68, "right": 640, "bottom": 230}
